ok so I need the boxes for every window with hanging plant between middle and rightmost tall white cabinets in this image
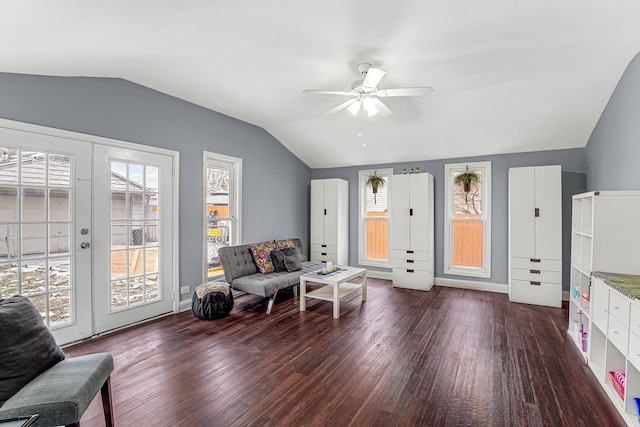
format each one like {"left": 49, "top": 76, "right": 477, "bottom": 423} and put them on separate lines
{"left": 444, "top": 162, "right": 491, "bottom": 277}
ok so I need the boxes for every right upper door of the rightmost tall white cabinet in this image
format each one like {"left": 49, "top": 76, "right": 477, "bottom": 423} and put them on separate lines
{"left": 535, "top": 166, "right": 562, "bottom": 259}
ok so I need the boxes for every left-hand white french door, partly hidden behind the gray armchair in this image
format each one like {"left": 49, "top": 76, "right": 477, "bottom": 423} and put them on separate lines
{"left": 0, "top": 128, "right": 92, "bottom": 343}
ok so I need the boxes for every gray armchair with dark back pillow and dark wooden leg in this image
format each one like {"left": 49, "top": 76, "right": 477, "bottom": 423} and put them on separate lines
{"left": 0, "top": 295, "right": 114, "bottom": 427}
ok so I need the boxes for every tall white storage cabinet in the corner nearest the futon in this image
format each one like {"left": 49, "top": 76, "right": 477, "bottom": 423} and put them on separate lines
{"left": 311, "top": 178, "right": 349, "bottom": 265}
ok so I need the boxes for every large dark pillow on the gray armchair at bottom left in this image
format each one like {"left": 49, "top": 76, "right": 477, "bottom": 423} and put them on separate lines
{"left": 0, "top": 295, "right": 64, "bottom": 406}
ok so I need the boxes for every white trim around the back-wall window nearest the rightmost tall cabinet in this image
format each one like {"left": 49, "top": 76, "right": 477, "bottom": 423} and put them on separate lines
{"left": 444, "top": 162, "right": 491, "bottom": 278}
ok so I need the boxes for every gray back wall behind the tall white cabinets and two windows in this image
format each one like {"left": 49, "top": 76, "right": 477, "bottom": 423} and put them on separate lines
{"left": 311, "top": 149, "right": 586, "bottom": 291}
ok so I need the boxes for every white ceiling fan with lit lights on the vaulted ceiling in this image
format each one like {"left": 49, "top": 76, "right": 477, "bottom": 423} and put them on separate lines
{"left": 303, "top": 62, "right": 433, "bottom": 117}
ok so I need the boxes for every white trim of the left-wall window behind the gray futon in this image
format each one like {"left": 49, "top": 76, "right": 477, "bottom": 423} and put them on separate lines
{"left": 200, "top": 151, "right": 242, "bottom": 283}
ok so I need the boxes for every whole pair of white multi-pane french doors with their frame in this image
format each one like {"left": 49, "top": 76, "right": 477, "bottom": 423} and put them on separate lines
{"left": 0, "top": 120, "right": 177, "bottom": 344}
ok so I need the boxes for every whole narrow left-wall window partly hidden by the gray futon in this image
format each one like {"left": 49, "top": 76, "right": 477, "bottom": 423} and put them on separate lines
{"left": 204, "top": 151, "right": 242, "bottom": 282}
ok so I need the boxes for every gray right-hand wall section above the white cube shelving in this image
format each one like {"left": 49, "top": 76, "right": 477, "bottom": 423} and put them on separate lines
{"left": 586, "top": 54, "right": 640, "bottom": 190}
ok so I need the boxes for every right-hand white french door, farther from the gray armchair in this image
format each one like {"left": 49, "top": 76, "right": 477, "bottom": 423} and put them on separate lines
{"left": 93, "top": 145, "right": 174, "bottom": 333}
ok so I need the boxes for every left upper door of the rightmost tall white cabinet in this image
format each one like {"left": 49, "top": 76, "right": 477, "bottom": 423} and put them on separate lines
{"left": 509, "top": 167, "right": 536, "bottom": 258}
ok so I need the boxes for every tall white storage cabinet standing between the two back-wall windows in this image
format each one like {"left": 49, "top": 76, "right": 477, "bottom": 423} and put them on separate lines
{"left": 391, "top": 173, "right": 434, "bottom": 291}
